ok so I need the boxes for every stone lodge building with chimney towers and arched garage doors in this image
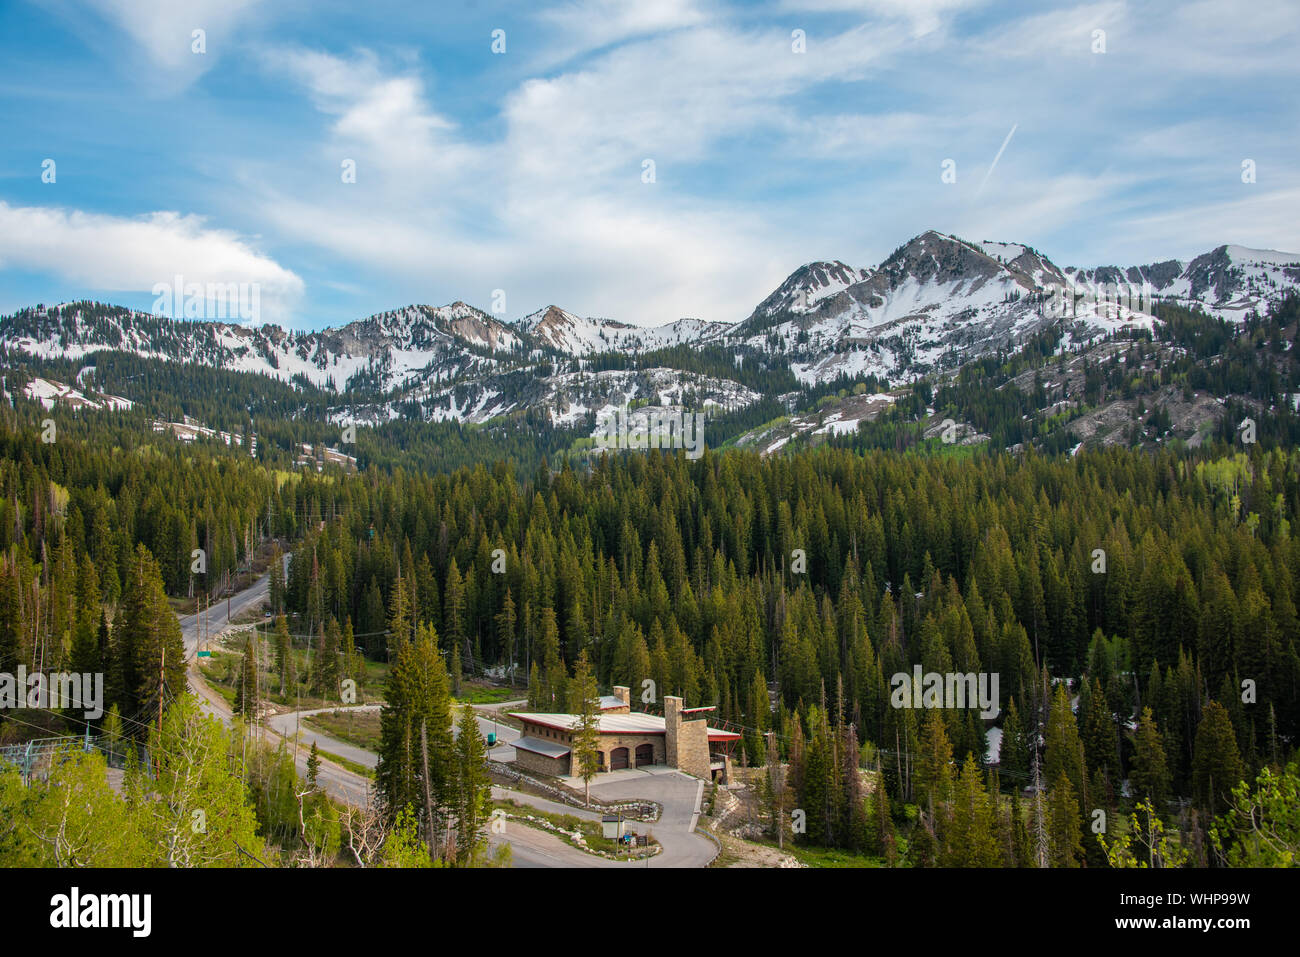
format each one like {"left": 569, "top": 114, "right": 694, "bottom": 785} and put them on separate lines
{"left": 511, "top": 687, "right": 740, "bottom": 784}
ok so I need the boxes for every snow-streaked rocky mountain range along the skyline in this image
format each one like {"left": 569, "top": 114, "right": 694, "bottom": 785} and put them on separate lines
{"left": 0, "top": 230, "right": 1300, "bottom": 423}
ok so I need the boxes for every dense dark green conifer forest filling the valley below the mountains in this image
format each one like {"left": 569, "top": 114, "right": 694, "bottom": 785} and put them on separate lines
{"left": 0, "top": 366, "right": 1300, "bottom": 867}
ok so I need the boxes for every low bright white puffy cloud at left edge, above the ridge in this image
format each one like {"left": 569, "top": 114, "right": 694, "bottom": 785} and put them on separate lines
{"left": 0, "top": 200, "right": 303, "bottom": 321}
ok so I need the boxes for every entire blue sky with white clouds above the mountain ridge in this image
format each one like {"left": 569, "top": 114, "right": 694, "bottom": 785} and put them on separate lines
{"left": 0, "top": 0, "right": 1300, "bottom": 329}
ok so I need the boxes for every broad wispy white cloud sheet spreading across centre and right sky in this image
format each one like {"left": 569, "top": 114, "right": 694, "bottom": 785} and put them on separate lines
{"left": 228, "top": 0, "right": 1296, "bottom": 324}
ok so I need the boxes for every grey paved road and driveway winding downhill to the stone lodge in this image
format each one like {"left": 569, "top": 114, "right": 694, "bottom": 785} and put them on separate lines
{"left": 172, "top": 566, "right": 714, "bottom": 867}
